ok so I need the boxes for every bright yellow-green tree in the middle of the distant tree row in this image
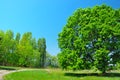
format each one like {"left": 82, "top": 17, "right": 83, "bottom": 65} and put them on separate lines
{"left": 18, "top": 32, "right": 34, "bottom": 67}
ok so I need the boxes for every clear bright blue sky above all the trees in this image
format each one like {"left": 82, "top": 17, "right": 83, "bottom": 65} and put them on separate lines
{"left": 0, "top": 0, "right": 120, "bottom": 55}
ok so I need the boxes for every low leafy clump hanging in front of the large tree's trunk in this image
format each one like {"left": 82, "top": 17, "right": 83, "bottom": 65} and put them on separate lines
{"left": 94, "top": 48, "right": 110, "bottom": 73}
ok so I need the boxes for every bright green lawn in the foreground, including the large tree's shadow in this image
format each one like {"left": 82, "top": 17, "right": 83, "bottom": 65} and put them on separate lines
{"left": 4, "top": 69, "right": 120, "bottom": 80}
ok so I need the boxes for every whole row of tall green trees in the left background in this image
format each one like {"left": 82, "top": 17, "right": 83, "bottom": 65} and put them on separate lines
{"left": 0, "top": 30, "right": 58, "bottom": 67}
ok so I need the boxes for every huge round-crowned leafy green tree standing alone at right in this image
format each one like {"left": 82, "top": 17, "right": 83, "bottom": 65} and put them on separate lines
{"left": 58, "top": 5, "right": 120, "bottom": 73}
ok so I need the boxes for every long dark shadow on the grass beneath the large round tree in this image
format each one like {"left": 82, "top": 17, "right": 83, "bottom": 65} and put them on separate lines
{"left": 64, "top": 72, "right": 120, "bottom": 77}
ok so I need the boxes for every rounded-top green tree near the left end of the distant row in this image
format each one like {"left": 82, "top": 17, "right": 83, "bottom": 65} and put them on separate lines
{"left": 3, "top": 30, "right": 15, "bottom": 65}
